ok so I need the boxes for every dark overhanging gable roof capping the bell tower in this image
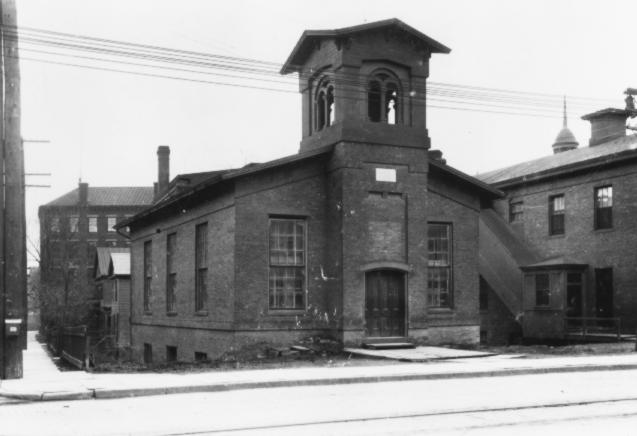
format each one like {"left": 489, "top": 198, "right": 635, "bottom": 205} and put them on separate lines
{"left": 281, "top": 18, "right": 451, "bottom": 74}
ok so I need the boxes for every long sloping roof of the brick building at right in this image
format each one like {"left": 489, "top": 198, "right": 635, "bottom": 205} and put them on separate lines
{"left": 476, "top": 135, "right": 637, "bottom": 187}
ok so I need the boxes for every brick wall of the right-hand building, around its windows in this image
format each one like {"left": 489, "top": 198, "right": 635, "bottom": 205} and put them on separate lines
{"left": 496, "top": 164, "right": 637, "bottom": 332}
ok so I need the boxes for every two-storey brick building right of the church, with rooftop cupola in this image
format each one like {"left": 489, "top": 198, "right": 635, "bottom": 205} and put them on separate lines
{"left": 479, "top": 104, "right": 637, "bottom": 340}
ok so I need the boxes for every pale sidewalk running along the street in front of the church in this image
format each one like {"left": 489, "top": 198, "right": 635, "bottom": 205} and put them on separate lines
{"left": 0, "top": 334, "right": 637, "bottom": 401}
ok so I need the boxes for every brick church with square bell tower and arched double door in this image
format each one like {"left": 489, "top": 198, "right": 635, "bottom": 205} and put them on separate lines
{"left": 118, "top": 19, "right": 502, "bottom": 361}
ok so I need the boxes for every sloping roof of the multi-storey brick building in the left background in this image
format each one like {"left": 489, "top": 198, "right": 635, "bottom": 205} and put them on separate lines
{"left": 45, "top": 186, "right": 154, "bottom": 206}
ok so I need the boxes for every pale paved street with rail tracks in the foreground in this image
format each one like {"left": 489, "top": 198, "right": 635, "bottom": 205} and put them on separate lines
{"left": 0, "top": 370, "right": 637, "bottom": 435}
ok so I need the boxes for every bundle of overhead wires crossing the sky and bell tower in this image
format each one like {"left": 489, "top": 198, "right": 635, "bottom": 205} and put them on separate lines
{"left": 2, "top": 27, "right": 620, "bottom": 117}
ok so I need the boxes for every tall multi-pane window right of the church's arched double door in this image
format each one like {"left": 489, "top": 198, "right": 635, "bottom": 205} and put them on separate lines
{"left": 427, "top": 223, "right": 452, "bottom": 308}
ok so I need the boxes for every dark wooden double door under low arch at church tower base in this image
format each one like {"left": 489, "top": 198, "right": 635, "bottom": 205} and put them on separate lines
{"left": 365, "top": 269, "right": 405, "bottom": 337}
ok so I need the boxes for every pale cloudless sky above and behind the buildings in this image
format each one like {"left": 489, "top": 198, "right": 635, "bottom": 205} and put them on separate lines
{"left": 17, "top": 0, "right": 637, "bottom": 264}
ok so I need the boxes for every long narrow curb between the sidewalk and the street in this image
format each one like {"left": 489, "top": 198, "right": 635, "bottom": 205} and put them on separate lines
{"left": 0, "top": 364, "right": 637, "bottom": 401}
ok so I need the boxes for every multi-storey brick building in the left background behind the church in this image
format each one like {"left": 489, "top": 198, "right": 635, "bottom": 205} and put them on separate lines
{"left": 38, "top": 183, "right": 154, "bottom": 328}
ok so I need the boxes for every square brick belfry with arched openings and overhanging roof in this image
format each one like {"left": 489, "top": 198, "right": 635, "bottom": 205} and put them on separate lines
{"left": 281, "top": 19, "right": 450, "bottom": 151}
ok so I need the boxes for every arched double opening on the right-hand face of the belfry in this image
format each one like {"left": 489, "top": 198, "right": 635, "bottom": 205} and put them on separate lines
{"left": 367, "top": 72, "right": 402, "bottom": 124}
